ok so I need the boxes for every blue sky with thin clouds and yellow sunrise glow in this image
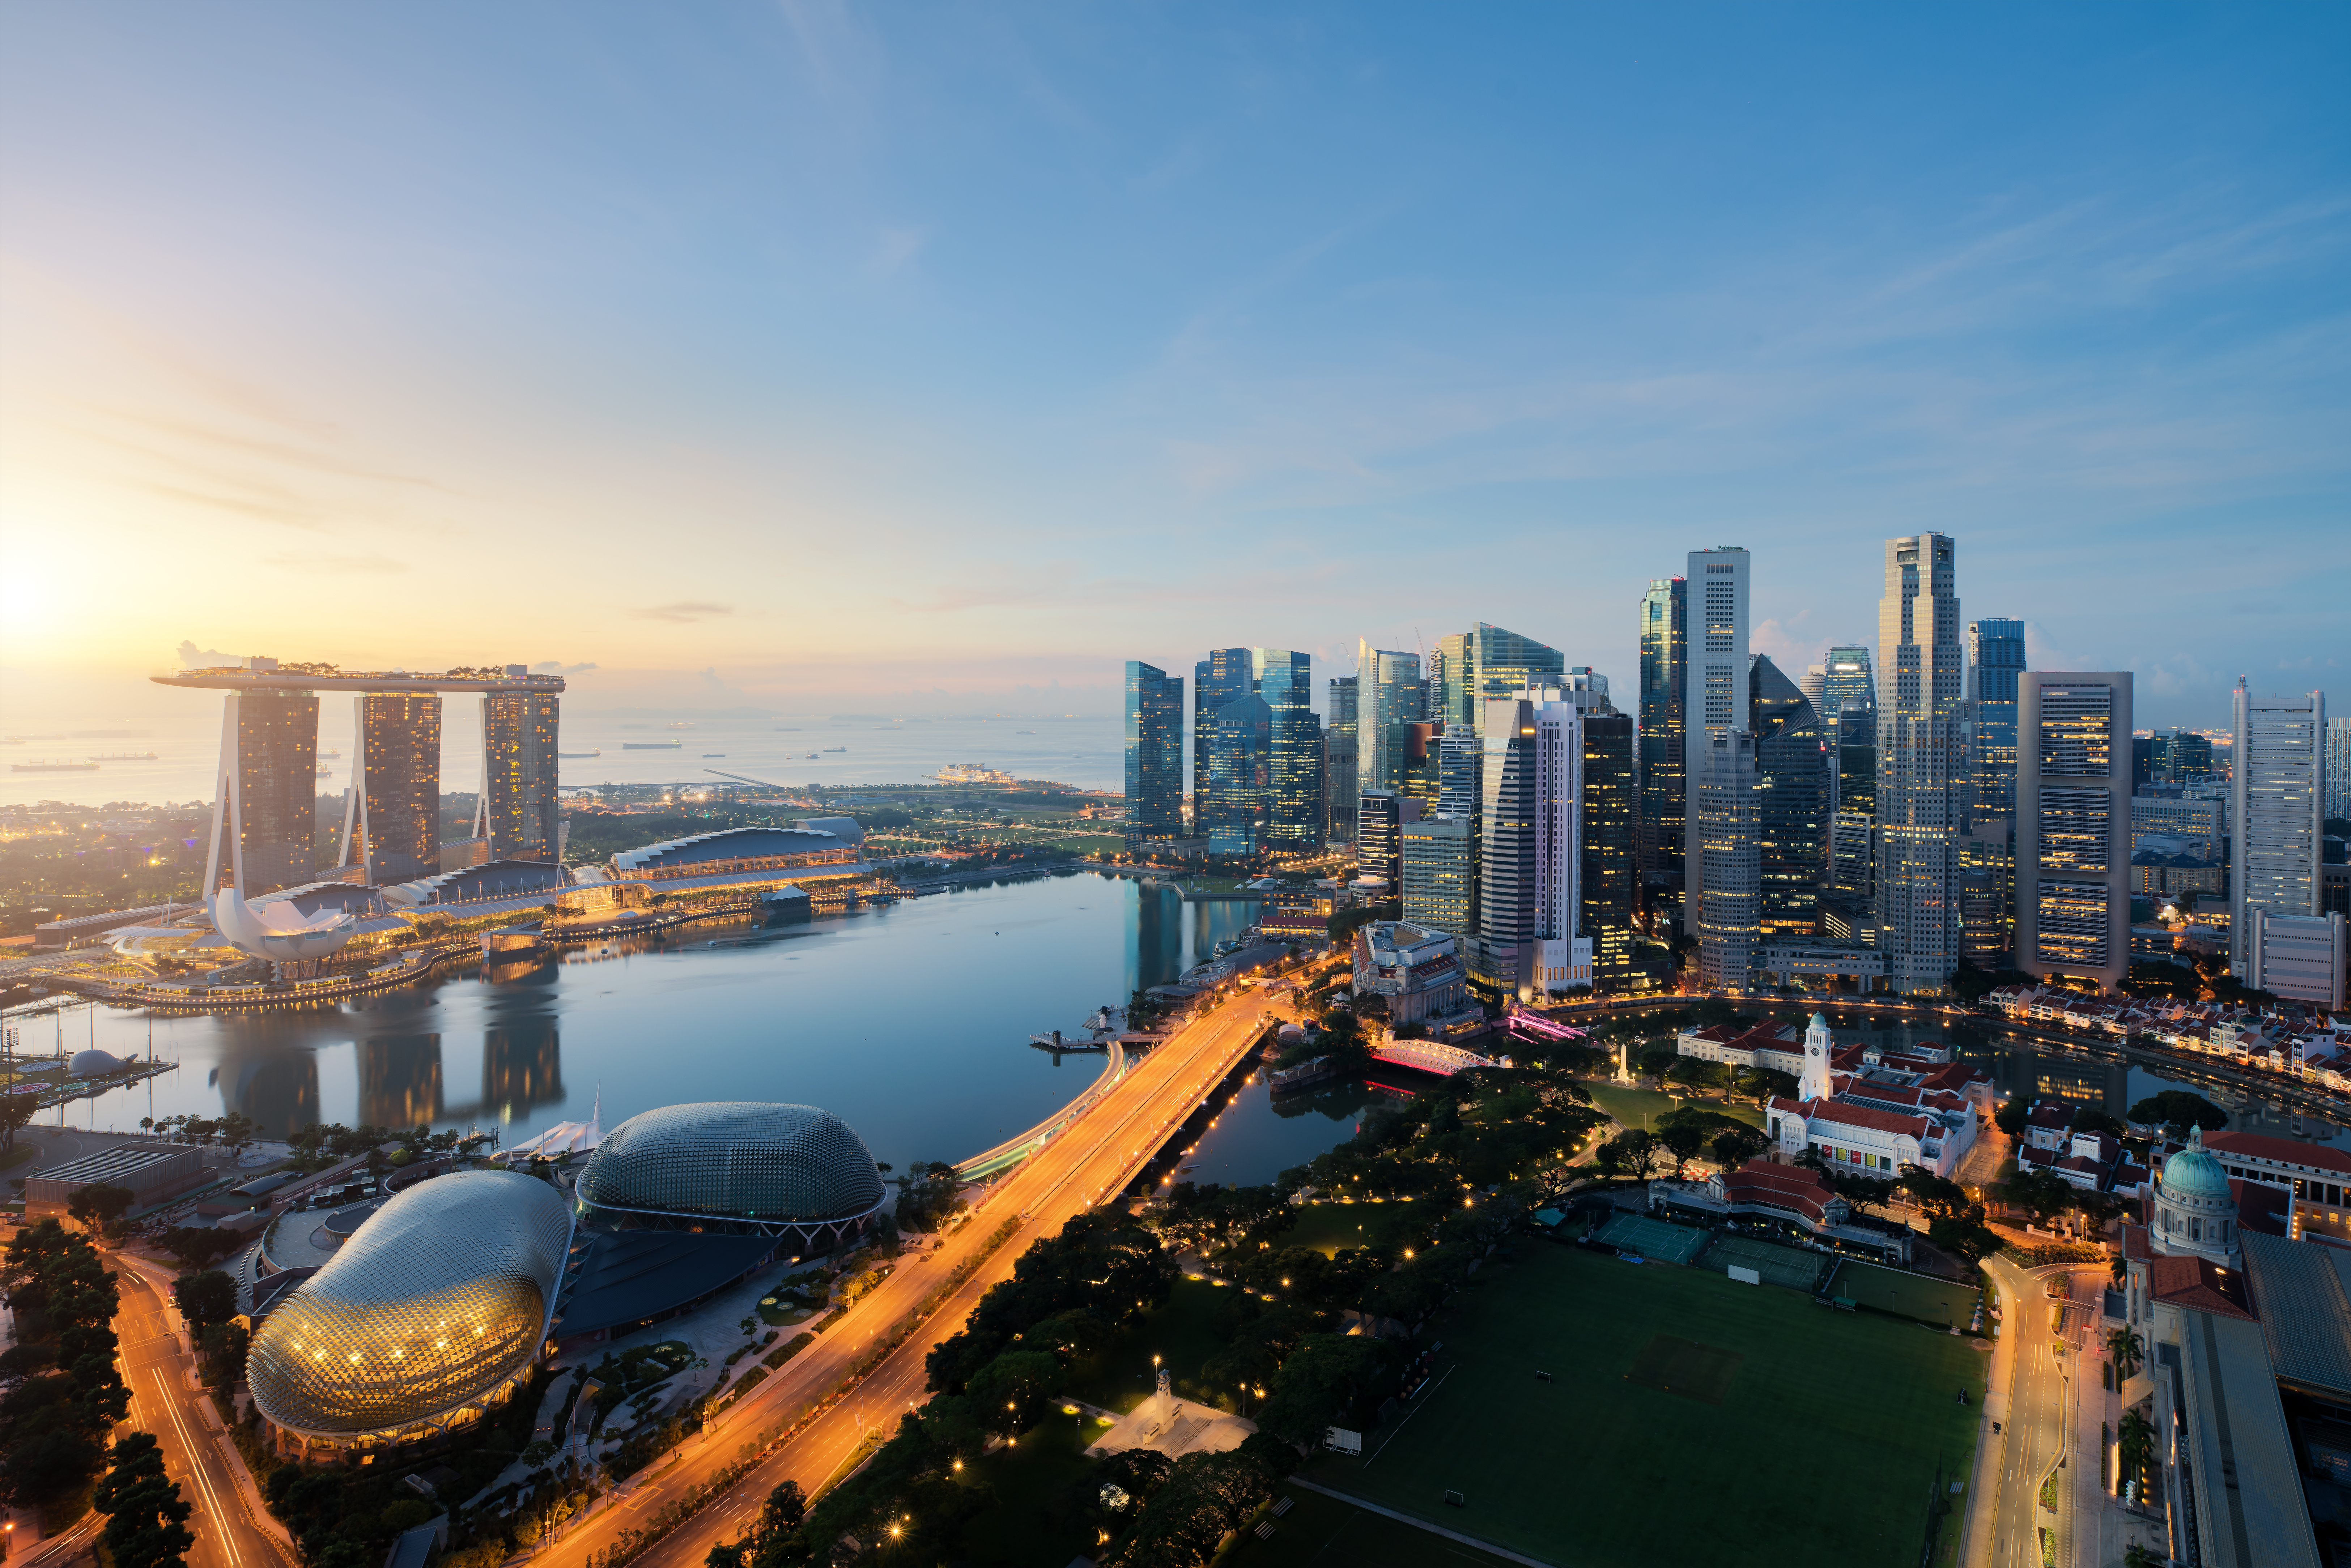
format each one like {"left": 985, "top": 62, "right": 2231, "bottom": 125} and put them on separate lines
{"left": 0, "top": 0, "right": 2351, "bottom": 731}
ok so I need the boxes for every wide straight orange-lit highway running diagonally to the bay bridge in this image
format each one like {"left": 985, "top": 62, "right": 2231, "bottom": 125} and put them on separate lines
{"left": 531, "top": 990, "right": 1277, "bottom": 1568}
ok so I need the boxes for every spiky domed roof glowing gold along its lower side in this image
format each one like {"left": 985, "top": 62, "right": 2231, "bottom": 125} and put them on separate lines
{"left": 247, "top": 1171, "right": 571, "bottom": 1441}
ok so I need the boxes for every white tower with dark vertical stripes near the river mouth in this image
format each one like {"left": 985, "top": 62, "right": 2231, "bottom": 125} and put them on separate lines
{"left": 1472, "top": 686, "right": 1592, "bottom": 997}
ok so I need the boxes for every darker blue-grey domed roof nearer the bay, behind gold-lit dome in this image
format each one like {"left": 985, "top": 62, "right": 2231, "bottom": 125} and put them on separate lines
{"left": 578, "top": 1100, "right": 884, "bottom": 1225}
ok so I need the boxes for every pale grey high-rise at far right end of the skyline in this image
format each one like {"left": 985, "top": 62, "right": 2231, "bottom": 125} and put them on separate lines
{"left": 2229, "top": 677, "right": 2327, "bottom": 980}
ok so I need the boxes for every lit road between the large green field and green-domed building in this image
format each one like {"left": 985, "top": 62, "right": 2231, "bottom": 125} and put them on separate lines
{"left": 1968, "top": 1255, "right": 2104, "bottom": 1568}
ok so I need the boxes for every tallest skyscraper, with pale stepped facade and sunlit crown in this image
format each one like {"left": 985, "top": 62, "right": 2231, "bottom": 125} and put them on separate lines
{"left": 1876, "top": 534, "right": 1968, "bottom": 994}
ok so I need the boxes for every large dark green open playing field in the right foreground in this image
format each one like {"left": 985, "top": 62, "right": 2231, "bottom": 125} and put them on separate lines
{"left": 1305, "top": 1246, "right": 1989, "bottom": 1568}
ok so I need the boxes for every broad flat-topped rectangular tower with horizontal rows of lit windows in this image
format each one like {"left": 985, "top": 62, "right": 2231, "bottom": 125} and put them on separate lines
{"left": 2015, "top": 670, "right": 2133, "bottom": 990}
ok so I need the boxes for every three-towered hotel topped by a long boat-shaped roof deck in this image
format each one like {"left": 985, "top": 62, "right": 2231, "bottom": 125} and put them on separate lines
{"left": 153, "top": 658, "right": 564, "bottom": 898}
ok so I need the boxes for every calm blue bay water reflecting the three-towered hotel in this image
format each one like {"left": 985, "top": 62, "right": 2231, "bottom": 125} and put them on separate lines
{"left": 46, "top": 874, "right": 1258, "bottom": 1166}
